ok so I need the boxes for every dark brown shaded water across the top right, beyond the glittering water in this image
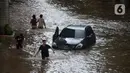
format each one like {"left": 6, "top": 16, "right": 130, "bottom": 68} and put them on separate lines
{"left": 47, "top": 0, "right": 130, "bottom": 21}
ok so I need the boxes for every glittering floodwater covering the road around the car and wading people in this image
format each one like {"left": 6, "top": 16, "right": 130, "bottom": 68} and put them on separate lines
{"left": 0, "top": 0, "right": 130, "bottom": 73}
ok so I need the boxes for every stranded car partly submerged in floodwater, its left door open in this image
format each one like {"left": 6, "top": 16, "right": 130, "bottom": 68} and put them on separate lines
{"left": 52, "top": 25, "right": 96, "bottom": 49}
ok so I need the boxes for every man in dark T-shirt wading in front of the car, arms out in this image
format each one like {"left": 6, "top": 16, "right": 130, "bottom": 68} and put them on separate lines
{"left": 34, "top": 39, "right": 54, "bottom": 60}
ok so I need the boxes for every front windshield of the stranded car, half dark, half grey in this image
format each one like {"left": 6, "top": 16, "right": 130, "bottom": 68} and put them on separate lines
{"left": 60, "top": 28, "right": 85, "bottom": 38}
